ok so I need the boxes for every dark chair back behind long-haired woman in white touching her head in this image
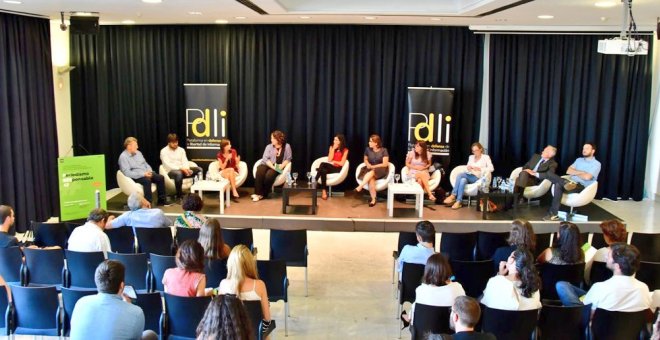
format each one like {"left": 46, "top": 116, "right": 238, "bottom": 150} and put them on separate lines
{"left": 481, "top": 305, "right": 539, "bottom": 340}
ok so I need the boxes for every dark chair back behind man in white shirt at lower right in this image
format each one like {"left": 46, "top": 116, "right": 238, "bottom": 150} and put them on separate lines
{"left": 591, "top": 308, "right": 648, "bottom": 340}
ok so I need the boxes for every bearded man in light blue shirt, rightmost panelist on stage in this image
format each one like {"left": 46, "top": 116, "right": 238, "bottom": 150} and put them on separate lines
{"left": 543, "top": 143, "right": 600, "bottom": 221}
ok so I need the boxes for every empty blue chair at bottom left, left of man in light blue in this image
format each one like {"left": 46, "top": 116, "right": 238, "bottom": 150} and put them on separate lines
{"left": 11, "top": 286, "right": 62, "bottom": 336}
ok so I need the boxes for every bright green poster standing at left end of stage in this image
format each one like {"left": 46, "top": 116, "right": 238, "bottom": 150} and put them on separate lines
{"left": 57, "top": 155, "right": 106, "bottom": 221}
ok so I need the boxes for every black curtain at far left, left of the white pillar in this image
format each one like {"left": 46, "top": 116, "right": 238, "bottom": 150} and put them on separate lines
{"left": 0, "top": 13, "right": 59, "bottom": 231}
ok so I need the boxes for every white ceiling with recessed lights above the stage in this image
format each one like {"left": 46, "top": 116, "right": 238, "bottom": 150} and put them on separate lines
{"left": 0, "top": 0, "right": 660, "bottom": 31}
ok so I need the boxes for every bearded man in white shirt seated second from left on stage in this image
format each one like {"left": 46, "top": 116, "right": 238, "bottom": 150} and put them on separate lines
{"left": 160, "top": 133, "right": 202, "bottom": 199}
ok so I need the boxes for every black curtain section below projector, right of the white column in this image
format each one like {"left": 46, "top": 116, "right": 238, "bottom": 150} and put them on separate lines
{"left": 489, "top": 35, "right": 652, "bottom": 200}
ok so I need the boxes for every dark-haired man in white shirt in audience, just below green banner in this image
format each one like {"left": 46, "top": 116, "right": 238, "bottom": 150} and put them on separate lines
{"left": 68, "top": 208, "right": 114, "bottom": 254}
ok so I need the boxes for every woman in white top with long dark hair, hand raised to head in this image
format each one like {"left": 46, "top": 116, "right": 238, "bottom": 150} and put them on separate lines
{"left": 481, "top": 248, "right": 541, "bottom": 310}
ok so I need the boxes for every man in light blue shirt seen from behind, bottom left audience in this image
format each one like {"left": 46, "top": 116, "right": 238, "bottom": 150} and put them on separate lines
{"left": 71, "top": 260, "right": 158, "bottom": 340}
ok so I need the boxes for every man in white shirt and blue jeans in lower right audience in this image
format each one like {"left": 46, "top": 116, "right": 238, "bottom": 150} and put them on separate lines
{"left": 556, "top": 243, "right": 651, "bottom": 315}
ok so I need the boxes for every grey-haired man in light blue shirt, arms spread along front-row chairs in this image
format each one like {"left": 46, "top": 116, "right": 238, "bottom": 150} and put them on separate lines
{"left": 106, "top": 192, "right": 172, "bottom": 228}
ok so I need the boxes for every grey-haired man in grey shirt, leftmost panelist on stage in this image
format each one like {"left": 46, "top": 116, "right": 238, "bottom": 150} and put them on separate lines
{"left": 119, "top": 137, "right": 167, "bottom": 205}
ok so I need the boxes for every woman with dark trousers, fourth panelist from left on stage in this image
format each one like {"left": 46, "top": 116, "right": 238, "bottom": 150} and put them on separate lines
{"left": 252, "top": 130, "right": 292, "bottom": 202}
